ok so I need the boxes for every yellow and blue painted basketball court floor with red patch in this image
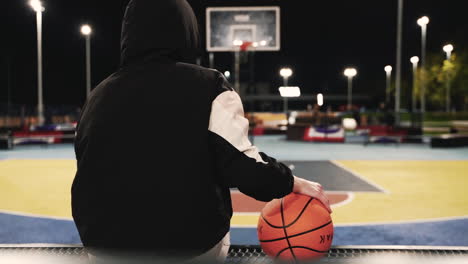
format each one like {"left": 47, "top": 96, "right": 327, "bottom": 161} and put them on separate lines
{"left": 0, "top": 136, "right": 468, "bottom": 246}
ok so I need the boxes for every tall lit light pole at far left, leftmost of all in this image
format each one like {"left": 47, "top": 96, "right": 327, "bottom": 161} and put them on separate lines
{"left": 29, "top": 0, "right": 45, "bottom": 125}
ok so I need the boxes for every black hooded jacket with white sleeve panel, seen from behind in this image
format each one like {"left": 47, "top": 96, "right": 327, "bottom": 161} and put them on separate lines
{"left": 72, "top": 0, "right": 293, "bottom": 257}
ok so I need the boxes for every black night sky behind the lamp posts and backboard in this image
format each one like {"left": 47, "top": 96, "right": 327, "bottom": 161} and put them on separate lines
{"left": 0, "top": 0, "right": 468, "bottom": 109}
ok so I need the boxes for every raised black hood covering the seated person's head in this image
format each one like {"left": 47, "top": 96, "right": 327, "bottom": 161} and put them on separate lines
{"left": 120, "top": 0, "right": 199, "bottom": 66}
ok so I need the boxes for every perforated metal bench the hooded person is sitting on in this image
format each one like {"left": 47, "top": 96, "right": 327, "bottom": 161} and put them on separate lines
{"left": 0, "top": 244, "right": 468, "bottom": 264}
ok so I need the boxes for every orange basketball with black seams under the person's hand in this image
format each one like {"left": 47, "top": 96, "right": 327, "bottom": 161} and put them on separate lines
{"left": 257, "top": 193, "right": 333, "bottom": 261}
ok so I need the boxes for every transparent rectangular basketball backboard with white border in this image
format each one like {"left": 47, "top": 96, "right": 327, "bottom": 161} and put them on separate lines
{"left": 206, "top": 6, "right": 280, "bottom": 52}
